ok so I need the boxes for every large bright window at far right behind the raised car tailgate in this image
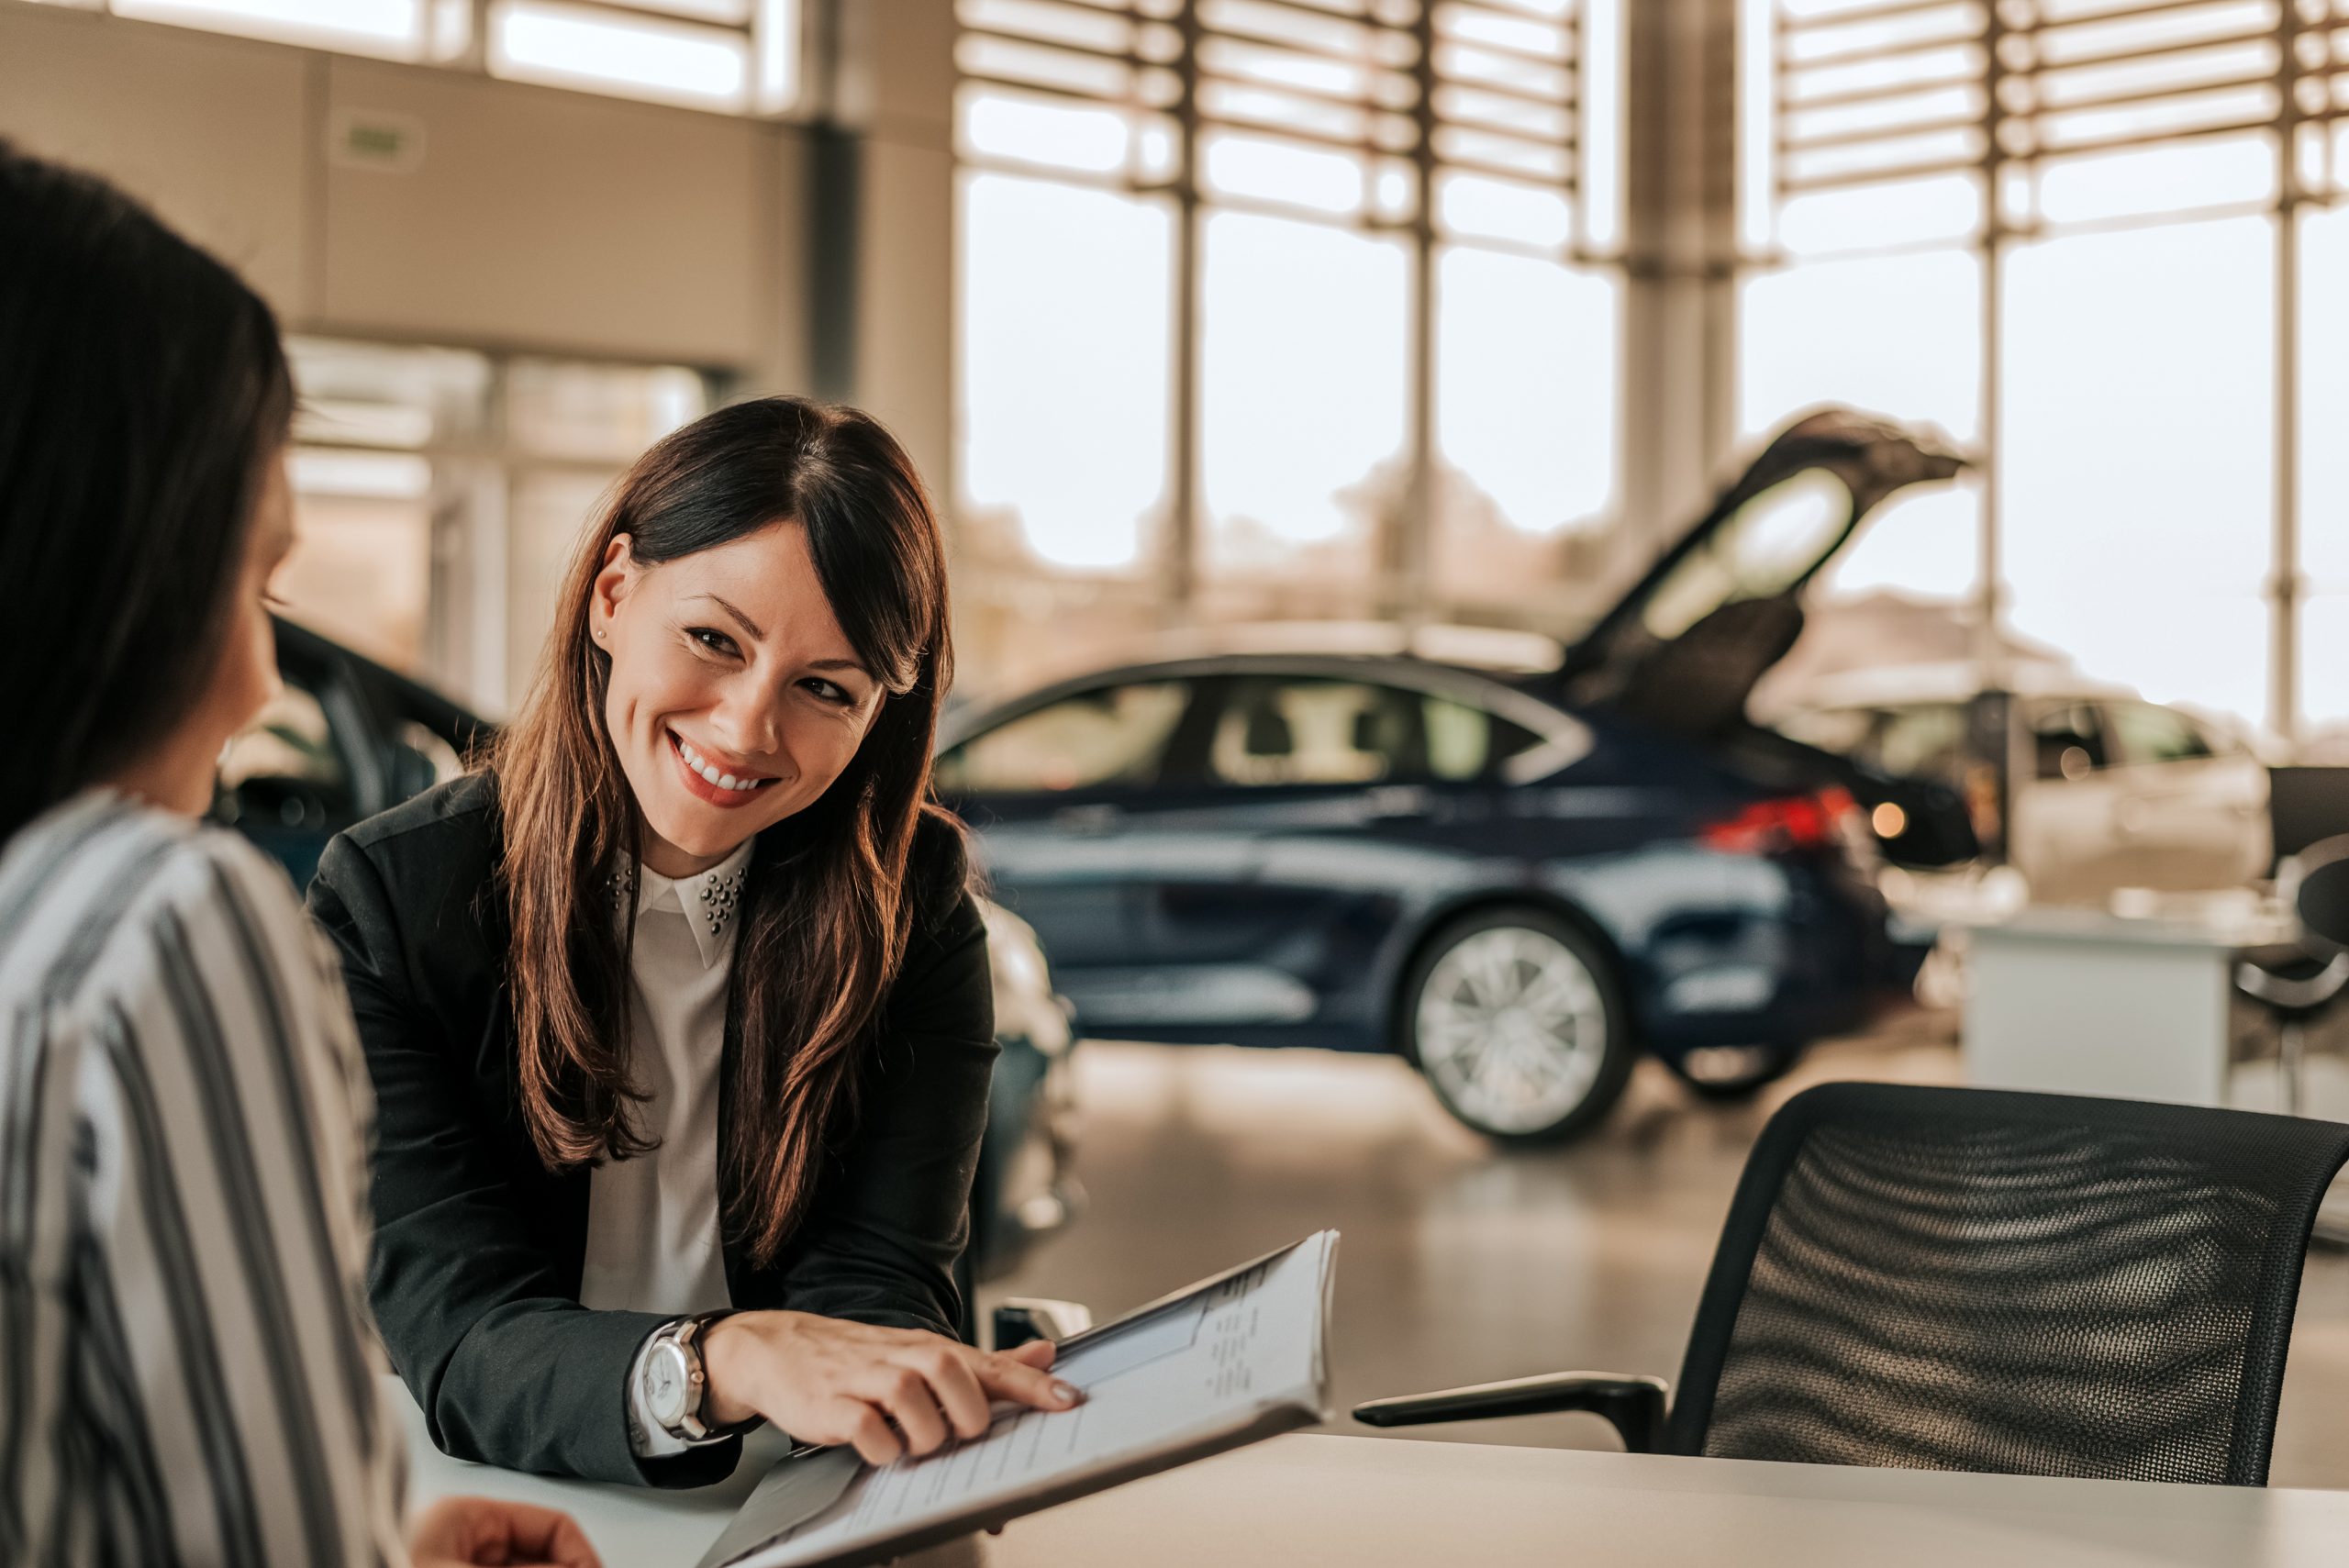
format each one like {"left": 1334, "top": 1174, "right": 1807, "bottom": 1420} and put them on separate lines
{"left": 1738, "top": 0, "right": 2349, "bottom": 732}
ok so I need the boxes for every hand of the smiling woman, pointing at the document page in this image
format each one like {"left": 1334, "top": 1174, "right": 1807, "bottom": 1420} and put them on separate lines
{"left": 702, "top": 1312, "right": 1081, "bottom": 1464}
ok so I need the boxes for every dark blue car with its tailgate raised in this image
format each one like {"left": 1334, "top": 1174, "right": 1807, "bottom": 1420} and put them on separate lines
{"left": 937, "top": 411, "right": 1976, "bottom": 1139}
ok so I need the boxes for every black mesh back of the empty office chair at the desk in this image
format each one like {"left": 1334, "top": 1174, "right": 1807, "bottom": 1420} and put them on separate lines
{"left": 1665, "top": 1084, "right": 2349, "bottom": 1485}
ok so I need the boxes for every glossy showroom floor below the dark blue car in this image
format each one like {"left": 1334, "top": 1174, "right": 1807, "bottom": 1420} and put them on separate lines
{"left": 989, "top": 1014, "right": 2349, "bottom": 1485}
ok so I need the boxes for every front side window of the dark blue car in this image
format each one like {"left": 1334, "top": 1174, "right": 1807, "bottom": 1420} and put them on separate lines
{"left": 935, "top": 681, "right": 1191, "bottom": 795}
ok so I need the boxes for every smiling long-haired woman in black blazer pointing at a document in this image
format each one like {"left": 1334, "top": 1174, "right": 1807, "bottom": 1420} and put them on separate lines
{"left": 310, "top": 396, "right": 1075, "bottom": 1485}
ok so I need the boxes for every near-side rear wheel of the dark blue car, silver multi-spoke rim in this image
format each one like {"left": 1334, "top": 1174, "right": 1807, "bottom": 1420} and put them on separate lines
{"left": 1396, "top": 906, "right": 1640, "bottom": 1143}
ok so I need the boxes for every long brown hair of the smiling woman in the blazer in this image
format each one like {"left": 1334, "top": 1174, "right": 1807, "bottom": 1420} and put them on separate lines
{"left": 488, "top": 396, "right": 961, "bottom": 1265}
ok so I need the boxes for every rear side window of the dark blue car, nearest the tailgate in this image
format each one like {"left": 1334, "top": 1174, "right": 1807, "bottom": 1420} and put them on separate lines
{"left": 1208, "top": 676, "right": 1539, "bottom": 789}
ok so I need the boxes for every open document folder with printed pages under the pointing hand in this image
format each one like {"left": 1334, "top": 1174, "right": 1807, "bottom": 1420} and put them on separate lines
{"left": 700, "top": 1230, "right": 1337, "bottom": 1568}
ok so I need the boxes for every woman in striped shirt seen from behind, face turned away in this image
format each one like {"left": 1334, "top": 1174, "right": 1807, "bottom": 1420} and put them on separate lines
{"left": 0, "top": 143, "right": 595, "bottom": 1568}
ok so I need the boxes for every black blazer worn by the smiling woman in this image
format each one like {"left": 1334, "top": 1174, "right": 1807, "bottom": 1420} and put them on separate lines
{"left": 310, "top": 774, "right": 996, "bottom": 1485}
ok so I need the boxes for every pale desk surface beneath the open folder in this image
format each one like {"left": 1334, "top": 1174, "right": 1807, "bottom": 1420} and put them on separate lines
{"left": 399, "top": 1395, "right": 2349, "bottom": 1568}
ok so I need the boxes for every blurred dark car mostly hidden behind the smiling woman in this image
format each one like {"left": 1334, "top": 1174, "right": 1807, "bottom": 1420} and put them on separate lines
{"left": 214, "top": 619, "right": 1075, "bottom": 1279}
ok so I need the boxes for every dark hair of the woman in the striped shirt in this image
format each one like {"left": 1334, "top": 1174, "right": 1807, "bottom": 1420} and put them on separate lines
{"left": 0, "top": 141, "right": 294, "bottom": 842}
